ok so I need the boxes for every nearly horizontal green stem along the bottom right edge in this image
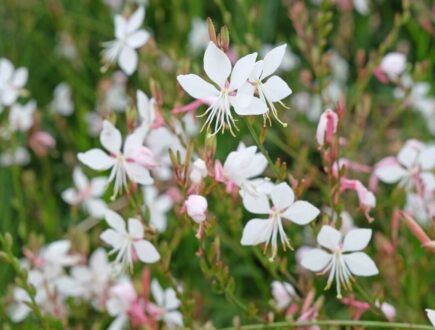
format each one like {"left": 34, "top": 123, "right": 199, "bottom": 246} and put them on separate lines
{"left": 221, "top": 320, "right": 434, "bottom": 330}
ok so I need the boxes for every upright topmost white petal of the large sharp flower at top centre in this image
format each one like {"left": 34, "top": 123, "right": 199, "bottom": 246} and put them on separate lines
{"left": 204, "top": 42, "right": 231, "bottom": 88}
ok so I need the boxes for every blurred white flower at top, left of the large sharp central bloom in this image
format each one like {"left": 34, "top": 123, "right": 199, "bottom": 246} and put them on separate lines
{"left": 103, "top": 6, "right": 149, "bottom": 75}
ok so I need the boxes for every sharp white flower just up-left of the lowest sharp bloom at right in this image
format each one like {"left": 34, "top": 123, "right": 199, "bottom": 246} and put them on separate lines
{"left": 241, "top": 182, "right": 320, "bottom": 259}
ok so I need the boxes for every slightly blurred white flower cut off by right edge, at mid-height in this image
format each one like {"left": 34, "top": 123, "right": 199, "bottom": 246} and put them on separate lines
{"left": 375, "top": 140, "right": 435, "bottom": 189}
